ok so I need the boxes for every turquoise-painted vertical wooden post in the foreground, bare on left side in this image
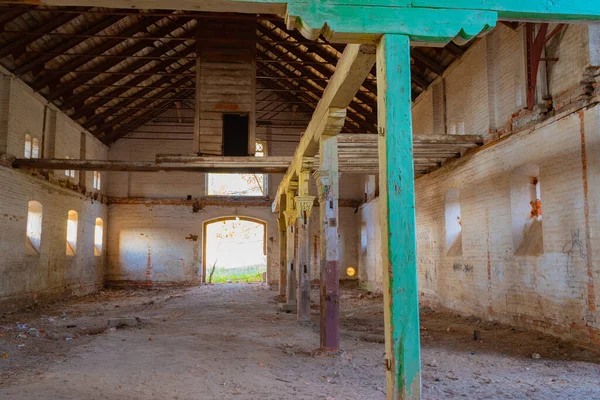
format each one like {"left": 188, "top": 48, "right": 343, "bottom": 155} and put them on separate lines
{"left": 377, "top": 35, "right": 421, "bottom": 400}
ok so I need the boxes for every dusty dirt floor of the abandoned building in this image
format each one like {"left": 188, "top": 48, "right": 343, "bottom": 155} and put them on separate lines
{"left": 0, "top": 284, "right": 600, "bottom": 400}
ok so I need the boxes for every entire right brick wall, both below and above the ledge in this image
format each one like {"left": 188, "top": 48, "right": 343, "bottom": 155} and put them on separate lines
{"left": 358, "top": 25, "right": 600, "bottom": 345}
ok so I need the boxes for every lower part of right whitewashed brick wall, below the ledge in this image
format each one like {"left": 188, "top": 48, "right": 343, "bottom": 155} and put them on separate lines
{"left": 359, "top": 106, "right": 600, "bottom": 344}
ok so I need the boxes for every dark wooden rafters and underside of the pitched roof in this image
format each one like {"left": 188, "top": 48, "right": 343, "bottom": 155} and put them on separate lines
{"left": 0, "top": 6, "right": 472, "bottom": 145}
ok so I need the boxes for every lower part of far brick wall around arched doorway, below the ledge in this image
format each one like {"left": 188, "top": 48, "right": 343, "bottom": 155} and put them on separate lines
{"left": 107, "top": 200, "right": 358, "bottom": 285}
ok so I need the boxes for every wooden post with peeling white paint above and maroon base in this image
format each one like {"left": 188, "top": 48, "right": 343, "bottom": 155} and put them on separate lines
{"left": 315, "top": 134, "right": 340, "bottom": 351}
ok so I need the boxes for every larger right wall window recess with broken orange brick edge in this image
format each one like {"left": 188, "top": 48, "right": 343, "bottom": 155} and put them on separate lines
{"left": 510, "top": 164, "right": 544, "bottom": 256}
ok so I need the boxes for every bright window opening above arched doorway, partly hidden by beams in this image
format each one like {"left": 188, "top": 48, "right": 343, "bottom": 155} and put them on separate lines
{"left": 206, "top": 141, "right": 268, "bottom": 196}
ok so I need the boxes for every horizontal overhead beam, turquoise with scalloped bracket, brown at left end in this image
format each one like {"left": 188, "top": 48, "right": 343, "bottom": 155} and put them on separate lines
{"left": 7, "top": 0, "right": 600, "bottom": 45}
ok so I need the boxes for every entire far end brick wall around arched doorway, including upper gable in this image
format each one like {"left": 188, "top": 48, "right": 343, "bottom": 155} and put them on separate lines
{"left": 107, "top": 104, "right": 363, "bottom": 284}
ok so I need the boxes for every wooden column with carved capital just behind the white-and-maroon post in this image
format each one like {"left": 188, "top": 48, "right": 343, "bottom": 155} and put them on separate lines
{"left": 294, "top": 163, "right": 315, "bottom": 322}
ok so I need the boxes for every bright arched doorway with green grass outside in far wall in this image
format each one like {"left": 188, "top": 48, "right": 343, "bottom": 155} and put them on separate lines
{"left": 202, "top": 216, "right": 267, "bottom": 283}
